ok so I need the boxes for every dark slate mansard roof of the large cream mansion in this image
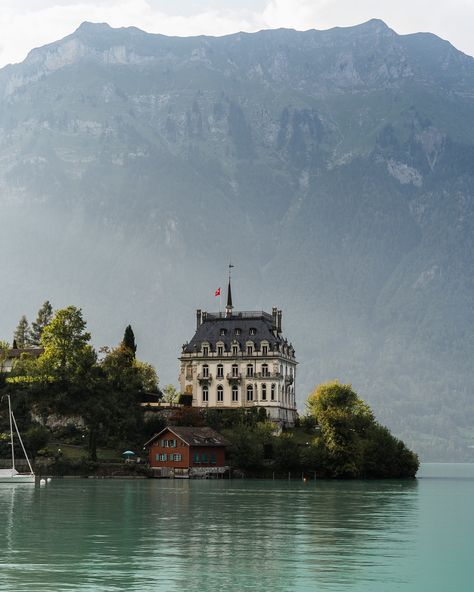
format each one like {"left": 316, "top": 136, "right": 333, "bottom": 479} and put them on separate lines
{"left": 183, "top": 311, "right": 287, "bottom": 354}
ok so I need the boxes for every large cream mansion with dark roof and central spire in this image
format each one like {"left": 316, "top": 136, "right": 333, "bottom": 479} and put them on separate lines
{"left": 179, "top": 281, "right": 297, "bottom": 426}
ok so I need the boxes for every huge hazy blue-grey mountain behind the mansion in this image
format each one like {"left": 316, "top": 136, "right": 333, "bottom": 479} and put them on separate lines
{"left": 0, "top": 20, "right": 474, "bottom": 460}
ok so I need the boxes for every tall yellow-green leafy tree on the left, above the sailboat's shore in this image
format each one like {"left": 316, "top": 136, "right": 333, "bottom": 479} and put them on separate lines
{"left": 40, "top": 306, "right": 97, "bottom": 382}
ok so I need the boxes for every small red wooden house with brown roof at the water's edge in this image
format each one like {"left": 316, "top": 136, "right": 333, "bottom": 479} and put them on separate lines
{"left": 145, "top": 427, "right": 229, "bottom": 478}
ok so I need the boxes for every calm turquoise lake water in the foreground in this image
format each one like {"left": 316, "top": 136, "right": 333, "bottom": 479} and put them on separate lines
{"left": 0, "top": 464, "right": 474, "bottom": 592}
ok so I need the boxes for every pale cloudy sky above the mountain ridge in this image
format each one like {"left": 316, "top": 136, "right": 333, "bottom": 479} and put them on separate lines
{"left": 0, "top": 0, "right": 474, "bottom": 66}
